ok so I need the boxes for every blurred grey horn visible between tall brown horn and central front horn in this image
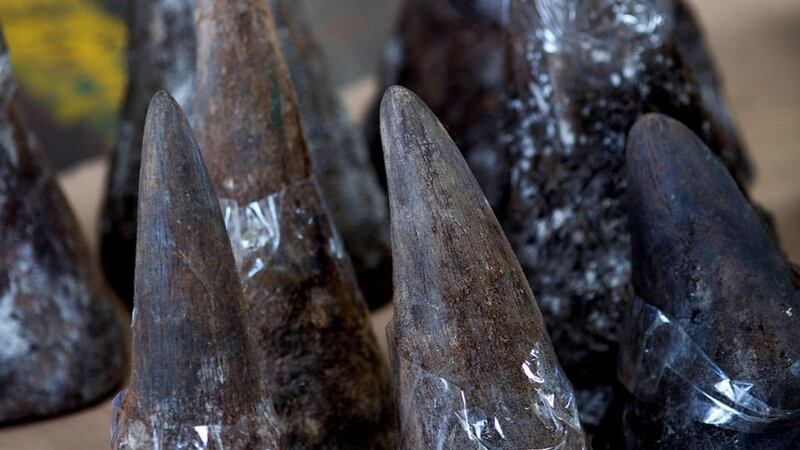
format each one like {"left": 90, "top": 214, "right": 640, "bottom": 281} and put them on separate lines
{"left": 272, "top": 0, "right": 392, "bottom": 309}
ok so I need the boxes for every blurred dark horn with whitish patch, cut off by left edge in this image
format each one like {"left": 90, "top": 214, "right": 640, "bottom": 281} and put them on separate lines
{"left": 0, "top": 25, "right": 125, "bottom": 423}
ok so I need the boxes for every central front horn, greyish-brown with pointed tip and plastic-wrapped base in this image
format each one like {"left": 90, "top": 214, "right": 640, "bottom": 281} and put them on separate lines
{"left": 381, "top": 87, "right": 586, "bottom": 449}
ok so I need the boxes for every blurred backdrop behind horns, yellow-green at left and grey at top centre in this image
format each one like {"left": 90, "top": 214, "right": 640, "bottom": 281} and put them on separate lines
{"left": 0, "top": 0, "right": 399, "bottom": 169}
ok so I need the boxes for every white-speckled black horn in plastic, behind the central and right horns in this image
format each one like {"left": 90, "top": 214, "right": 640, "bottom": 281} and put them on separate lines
{"left": 499, "top": 0, "right": 748, "bottom": 425}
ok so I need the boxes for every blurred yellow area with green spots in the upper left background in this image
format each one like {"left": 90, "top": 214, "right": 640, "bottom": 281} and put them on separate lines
{"left": 0, "top": 0, "right": 127, "bottom": 138}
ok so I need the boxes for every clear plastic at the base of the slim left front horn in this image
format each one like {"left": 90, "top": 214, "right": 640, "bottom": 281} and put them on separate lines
{"left": 111, "top": 390, "right": 279, "bottom": 450}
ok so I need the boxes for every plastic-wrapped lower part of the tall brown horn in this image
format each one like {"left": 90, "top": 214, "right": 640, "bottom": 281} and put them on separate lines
{"left": 220, "top": 177, "right": 394, "bottom": 449}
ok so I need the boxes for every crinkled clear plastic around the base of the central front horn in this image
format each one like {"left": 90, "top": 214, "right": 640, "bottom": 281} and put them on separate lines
{"left": 386, "top": 322, "right": 588, "bottom": 450}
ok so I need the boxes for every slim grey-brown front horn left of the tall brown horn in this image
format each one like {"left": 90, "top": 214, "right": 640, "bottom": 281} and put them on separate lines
{"left": 112, "top": 92, "right": 277, "bottom": 449}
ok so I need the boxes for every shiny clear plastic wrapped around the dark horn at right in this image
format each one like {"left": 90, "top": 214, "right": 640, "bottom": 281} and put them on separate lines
{"left": 619, "top": 297, "right": 800, "bottom": 433}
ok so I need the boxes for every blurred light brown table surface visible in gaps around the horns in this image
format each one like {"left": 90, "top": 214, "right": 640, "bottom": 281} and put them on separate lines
{"left": 0, "top": 0, "right": 800, "bottom": 450}
